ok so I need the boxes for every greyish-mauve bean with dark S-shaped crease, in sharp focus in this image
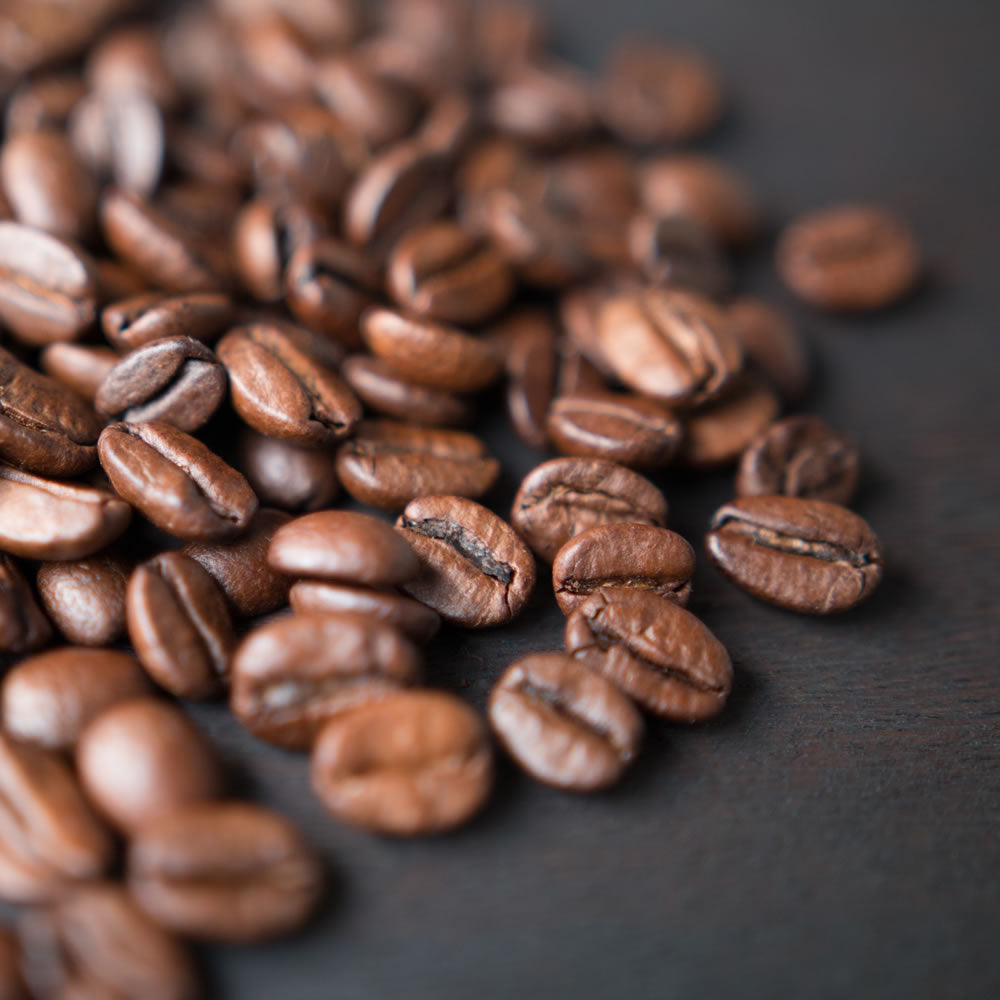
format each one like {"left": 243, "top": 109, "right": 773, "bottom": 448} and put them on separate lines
{"left": 94, "top": 337, "right": 227, "bottom": 431}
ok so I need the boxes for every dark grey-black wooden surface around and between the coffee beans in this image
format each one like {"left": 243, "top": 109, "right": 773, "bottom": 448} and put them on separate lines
{"left": 184, "top": 0, "right": 1000, "bottom": 1000}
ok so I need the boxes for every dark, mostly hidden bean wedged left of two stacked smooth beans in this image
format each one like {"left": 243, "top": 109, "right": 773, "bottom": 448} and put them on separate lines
{"left": 182, "top": 508, "right": 290, "bottom": 618}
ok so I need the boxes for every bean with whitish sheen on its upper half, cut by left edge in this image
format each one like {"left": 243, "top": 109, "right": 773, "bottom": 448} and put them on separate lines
{"left": 0, "top": 222, "right": 97, "bottom": 347}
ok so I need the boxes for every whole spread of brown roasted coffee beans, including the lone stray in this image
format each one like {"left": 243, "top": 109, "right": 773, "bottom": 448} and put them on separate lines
{"left": 0, "top": 0, "right": 920, "bottom": 988}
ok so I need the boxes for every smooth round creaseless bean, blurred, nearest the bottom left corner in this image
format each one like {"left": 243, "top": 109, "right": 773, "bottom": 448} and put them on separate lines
{"left": 76, "top": 698, "right": 222, "bottom": 834}
